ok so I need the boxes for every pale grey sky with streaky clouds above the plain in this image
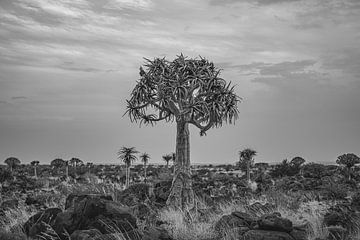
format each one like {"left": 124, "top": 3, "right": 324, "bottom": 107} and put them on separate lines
{"left": 0, "top": 0, "right": 360, "bottom": 163}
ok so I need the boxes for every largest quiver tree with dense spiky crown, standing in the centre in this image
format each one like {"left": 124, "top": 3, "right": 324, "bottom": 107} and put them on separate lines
{"left": 126, "top": 54, "right": 240, "bottom": 208}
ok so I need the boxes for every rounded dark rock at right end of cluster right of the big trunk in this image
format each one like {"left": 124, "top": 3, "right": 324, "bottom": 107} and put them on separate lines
{"left": 258, "top": 214, "right": 293, "bottom": 233}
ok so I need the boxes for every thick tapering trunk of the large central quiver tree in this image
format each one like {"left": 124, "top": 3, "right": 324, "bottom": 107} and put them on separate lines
{"left": 166, "top": 120, "right": 194, "bottom": 209}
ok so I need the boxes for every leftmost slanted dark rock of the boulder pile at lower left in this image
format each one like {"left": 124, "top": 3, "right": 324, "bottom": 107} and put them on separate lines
{"left": 23, "top": 208, "right": 61, "bottom": 237}
